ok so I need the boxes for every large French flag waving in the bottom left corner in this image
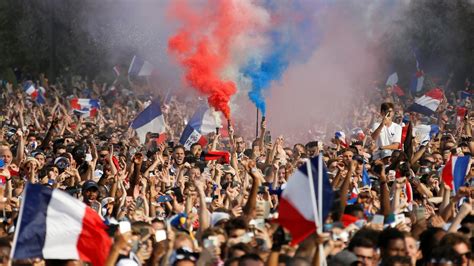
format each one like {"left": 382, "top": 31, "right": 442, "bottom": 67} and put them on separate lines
{"left": 11, "top": 184, "right": 112, "bottom": 265}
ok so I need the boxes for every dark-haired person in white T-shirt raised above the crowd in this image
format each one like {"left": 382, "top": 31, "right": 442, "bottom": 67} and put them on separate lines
{"left": 371, "top": 102, "right": 402, "bottom": 156}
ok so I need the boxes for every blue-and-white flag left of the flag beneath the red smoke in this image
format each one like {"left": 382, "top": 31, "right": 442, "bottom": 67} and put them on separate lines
{"left": 130, "top": 100, "right": 166, "bottom": 143}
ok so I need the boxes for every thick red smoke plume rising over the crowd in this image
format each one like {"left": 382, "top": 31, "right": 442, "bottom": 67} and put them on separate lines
{"left": 168, "top": 0, "right": 262, "bottom": 119}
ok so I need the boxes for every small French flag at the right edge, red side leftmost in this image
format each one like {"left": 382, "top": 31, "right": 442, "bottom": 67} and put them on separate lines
{"left": 441, "top": 155, "right": 471, "bottom": 191}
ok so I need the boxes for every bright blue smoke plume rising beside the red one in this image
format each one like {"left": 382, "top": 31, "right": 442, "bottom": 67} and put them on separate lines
{"left": 241, "top": 1, "right": 321, "bottom": 115}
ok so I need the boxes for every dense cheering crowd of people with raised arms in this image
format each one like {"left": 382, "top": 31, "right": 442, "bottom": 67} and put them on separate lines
{"left": 0, "top": 70, "right": 474, "bottom": 266}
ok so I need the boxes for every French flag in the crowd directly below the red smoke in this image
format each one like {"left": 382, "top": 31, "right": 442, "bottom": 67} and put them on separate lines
{"left": 179, "top": 105, "right": 222, "bottom": 149}
